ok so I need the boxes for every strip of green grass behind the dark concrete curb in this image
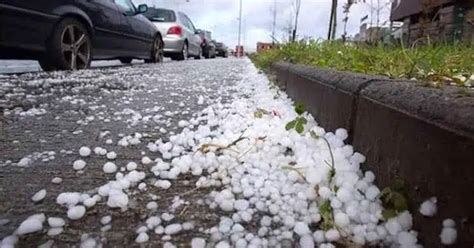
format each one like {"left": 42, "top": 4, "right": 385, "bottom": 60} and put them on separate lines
{"left": 251, "top": 41, "right": 474, "bottom": 86}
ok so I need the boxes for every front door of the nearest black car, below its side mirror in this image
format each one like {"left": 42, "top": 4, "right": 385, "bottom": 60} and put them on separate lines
{"left": 115, "top": 0, "right": 153, "bottom": 57}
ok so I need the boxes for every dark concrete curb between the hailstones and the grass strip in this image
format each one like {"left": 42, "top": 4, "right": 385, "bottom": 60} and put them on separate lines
{"left": 272, "top": 63, "right": 474, "bottom": 247}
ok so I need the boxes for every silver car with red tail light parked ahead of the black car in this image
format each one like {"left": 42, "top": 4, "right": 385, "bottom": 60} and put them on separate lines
{"left": 144, "top": 8, "right": 202, "bottom": 60}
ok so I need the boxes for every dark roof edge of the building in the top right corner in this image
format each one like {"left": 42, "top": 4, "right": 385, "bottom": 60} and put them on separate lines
{"left": 390, "top": 0, "right": 456, "bottom": 21}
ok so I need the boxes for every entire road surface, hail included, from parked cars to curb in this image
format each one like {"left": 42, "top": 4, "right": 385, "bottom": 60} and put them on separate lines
{"left": 0, "top": 58, "right": 422, "bottom": 248}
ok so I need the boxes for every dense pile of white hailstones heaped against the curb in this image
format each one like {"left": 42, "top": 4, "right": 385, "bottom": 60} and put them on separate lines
{"left": 2, "top": 60, "right": 456, "bottom": 248}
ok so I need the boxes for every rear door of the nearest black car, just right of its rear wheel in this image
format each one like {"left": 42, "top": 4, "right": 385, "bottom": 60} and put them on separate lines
{"left": 77, "top": 0, "right": 122, "bottom": 59}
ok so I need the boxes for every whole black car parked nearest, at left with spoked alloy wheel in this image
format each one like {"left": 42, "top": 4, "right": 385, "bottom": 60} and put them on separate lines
{"left": 0, "top": 0, "right": 163, "bottom": 71}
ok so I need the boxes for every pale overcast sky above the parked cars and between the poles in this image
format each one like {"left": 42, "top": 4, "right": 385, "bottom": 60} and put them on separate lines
{"left": 134, "top": 0, "right": 390, "bottom": 51}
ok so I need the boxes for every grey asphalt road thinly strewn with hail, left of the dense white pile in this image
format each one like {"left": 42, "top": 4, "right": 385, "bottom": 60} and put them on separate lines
{"left": 0, "top": 59, "right": 245, "bottom": 247}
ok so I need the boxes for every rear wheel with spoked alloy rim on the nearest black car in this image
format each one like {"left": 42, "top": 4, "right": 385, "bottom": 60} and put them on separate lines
{"left": 41, "top": 18, "right": 92, "bottom": 70}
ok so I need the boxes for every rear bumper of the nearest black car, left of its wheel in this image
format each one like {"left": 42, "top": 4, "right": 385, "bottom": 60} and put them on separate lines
{"left": 0, "top": 4, "right": 59, "bottom": 59}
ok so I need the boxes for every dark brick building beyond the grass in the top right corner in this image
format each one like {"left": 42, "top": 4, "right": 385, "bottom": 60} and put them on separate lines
{"left": 390, "top": 0, "right": 474, "bottom": 44}
